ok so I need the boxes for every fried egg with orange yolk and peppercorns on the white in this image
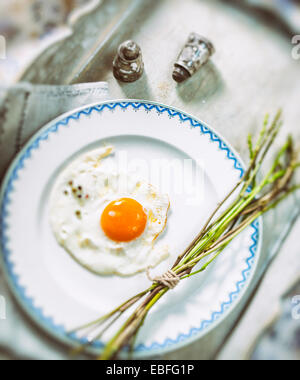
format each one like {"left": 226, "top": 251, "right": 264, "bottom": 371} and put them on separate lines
{"left": 50, "top": 146, "right": 170, "bottom": 276}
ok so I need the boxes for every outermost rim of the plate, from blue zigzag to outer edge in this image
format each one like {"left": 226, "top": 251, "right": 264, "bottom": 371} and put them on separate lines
{"left": 0, "top": 99, "right": 263, "bottom": 358}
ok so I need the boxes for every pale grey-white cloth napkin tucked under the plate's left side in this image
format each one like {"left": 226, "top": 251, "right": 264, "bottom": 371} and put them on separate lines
{"left": 0, "top": 82, "right": 108, "bottom": 359}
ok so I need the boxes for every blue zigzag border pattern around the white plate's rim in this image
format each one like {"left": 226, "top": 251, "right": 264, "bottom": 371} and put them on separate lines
{"left": 0, "top": 102, "right": 259, "bottom": 352}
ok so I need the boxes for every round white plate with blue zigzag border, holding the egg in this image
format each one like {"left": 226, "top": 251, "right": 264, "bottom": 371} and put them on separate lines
{"left": 1, "top": 101, "right": 261, "bottom": 357}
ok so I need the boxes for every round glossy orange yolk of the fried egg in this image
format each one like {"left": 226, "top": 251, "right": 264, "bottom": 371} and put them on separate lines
{"left": 101, "top": 198, "right": 147, "bottom": 243}
